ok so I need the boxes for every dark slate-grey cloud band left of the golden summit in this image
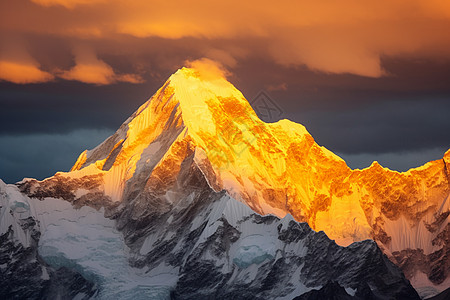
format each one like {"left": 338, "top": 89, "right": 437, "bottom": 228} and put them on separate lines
{"left": 0, "top": 78, "right": 161, "bottom": 134}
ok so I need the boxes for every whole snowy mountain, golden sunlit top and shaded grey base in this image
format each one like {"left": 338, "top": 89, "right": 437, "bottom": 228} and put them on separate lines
{"left": 0, "top": 68, "right": 450, "bottom": 300}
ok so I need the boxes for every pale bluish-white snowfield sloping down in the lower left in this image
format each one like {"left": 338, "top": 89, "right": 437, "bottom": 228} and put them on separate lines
{"left": 0, "top": 180, "right": 177, "bottom": 299}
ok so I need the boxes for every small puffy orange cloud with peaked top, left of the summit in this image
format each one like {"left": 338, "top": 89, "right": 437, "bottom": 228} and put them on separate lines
{"left": 58, "top": 49, "right": 143, "bottom": 85}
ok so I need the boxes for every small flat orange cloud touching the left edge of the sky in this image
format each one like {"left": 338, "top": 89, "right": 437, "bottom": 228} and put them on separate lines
{"left": 0, "top": 60, "right": 54, "bottom": 84}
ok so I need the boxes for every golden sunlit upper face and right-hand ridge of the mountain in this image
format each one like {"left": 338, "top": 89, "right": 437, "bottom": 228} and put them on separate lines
{"left": 54, "top": 68, "right": 450, "bottom": 289}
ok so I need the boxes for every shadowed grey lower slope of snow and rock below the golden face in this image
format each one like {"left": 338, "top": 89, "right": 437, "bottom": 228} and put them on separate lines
{"left": 0, "top": 163, "right": 419, "bottom": 299}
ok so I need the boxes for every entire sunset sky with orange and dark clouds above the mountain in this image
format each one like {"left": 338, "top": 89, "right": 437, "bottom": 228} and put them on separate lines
{"left": 0, "top": 0, "right": 450, "bottom": 183}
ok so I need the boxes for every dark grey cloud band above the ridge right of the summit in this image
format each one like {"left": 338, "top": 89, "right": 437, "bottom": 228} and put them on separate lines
{"left": 297, "top": 99, "right": 450, "bottom": 154}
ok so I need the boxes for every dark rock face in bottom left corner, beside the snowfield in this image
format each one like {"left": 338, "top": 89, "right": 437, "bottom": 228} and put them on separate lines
{"left": 0, "top": 217, "right": 96, "bottom": 299}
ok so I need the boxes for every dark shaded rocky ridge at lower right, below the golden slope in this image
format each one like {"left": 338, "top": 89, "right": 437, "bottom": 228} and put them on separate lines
{"left": 173, "top": 222, "right": 419, "bottom": 299}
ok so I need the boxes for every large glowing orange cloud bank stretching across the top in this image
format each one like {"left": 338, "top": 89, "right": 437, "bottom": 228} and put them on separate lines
{"left": 0, "top": 0, "right": 450, "bottom": 77}
